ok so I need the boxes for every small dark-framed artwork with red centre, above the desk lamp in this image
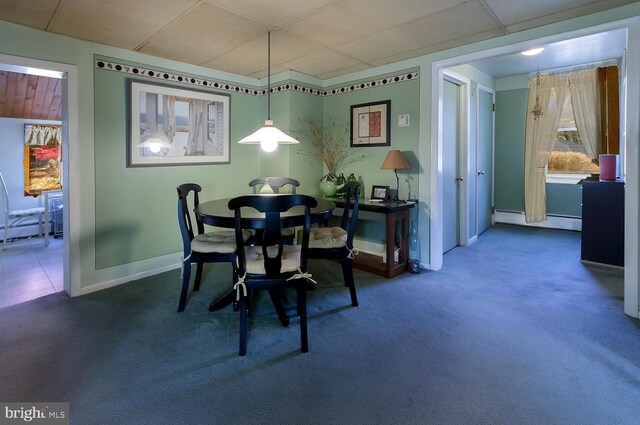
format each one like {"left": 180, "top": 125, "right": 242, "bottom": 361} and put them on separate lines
{"left": 351, "top": 100, "right": 391, "bottom": 147}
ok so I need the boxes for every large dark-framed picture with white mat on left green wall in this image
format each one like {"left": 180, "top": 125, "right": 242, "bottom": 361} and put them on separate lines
{"left": 127, "top": 79, "right": 231, "bottom": 167}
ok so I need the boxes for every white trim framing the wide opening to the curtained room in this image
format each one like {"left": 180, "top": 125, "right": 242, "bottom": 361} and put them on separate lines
{"left": 428, "top": 18, "right": 640, "bottom": 317}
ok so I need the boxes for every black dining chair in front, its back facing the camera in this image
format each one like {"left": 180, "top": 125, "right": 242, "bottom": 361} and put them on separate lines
{"left": 229, "top": 194, "right": 317, "bottom": 356}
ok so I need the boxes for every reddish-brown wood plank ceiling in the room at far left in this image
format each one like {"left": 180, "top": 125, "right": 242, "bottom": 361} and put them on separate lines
{"left": 0, "top": 71, "right": 62, "bottom": 121}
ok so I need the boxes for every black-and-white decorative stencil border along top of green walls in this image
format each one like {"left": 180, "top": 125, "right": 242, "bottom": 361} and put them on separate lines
{"left": 95, "top": 58, "right": 419, "bottom": 96}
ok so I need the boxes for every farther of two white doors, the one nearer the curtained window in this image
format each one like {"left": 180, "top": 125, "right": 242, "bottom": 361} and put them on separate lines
{"left": 476, "top": 85, "right": 494, "bottom": 235}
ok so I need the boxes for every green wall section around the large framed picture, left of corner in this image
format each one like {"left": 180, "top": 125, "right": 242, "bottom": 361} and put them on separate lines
{"left": 94, "top": 58, "right": 259, "bottom": 269}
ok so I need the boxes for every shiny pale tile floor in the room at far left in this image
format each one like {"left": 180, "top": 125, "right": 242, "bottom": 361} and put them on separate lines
{"left": 0, "top": 237, "right": 63, "bottom": 308}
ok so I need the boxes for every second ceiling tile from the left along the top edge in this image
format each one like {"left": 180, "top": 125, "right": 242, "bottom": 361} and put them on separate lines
{"left": 49, "top": 0, "right": 197, "bottom": 49}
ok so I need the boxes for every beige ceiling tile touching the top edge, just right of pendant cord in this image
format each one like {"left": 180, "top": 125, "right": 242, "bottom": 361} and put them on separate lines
{"left": 283, "top": 0, "right": 468, "bottom": 47}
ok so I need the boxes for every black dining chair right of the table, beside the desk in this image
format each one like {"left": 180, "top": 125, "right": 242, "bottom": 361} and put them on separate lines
{"left": 309, "top": 182, "right": 361, "bottom": 307}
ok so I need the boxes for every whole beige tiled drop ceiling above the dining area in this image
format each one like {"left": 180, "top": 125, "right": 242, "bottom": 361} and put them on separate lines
{"left": 0, "top": 0, "right": 635, "bottom": 78}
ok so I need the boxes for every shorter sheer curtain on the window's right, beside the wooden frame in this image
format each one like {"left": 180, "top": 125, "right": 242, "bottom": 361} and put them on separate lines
{"left": 569, "top": 68, "right": 601, "bottom": 160}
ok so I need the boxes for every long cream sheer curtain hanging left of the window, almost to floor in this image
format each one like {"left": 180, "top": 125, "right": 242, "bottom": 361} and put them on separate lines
{"left": 524, "top": 75, "right": 568, "bottom": 223}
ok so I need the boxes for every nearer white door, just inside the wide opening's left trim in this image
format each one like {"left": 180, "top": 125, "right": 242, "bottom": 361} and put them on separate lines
{"left": 442, "top": 80, "right": 460, "bottom": 253}
